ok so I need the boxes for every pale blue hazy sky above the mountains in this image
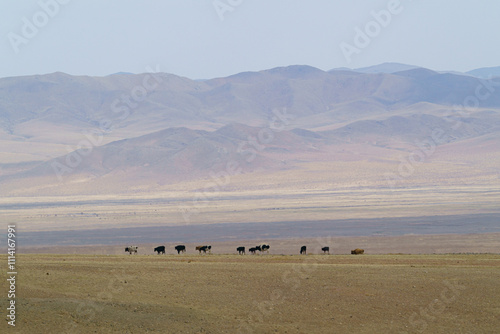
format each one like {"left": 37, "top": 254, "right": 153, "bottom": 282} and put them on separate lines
{"left": 0, "top": 0, "right": 500, "bottom": 79}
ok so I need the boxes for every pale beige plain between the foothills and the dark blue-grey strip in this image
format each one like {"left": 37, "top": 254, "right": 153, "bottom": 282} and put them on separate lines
{"left": 0, "top": 153, "right": 500, "bottom": 232}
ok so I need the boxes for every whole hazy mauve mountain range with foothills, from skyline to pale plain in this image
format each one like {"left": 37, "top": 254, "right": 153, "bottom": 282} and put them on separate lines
{"left": 0, "top": 63, "right": 500, "bottom": 196}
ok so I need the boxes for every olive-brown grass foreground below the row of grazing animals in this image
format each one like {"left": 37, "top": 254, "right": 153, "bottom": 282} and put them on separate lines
{"left": 0, "top": 254, "right": 500, "bottom": 333}
